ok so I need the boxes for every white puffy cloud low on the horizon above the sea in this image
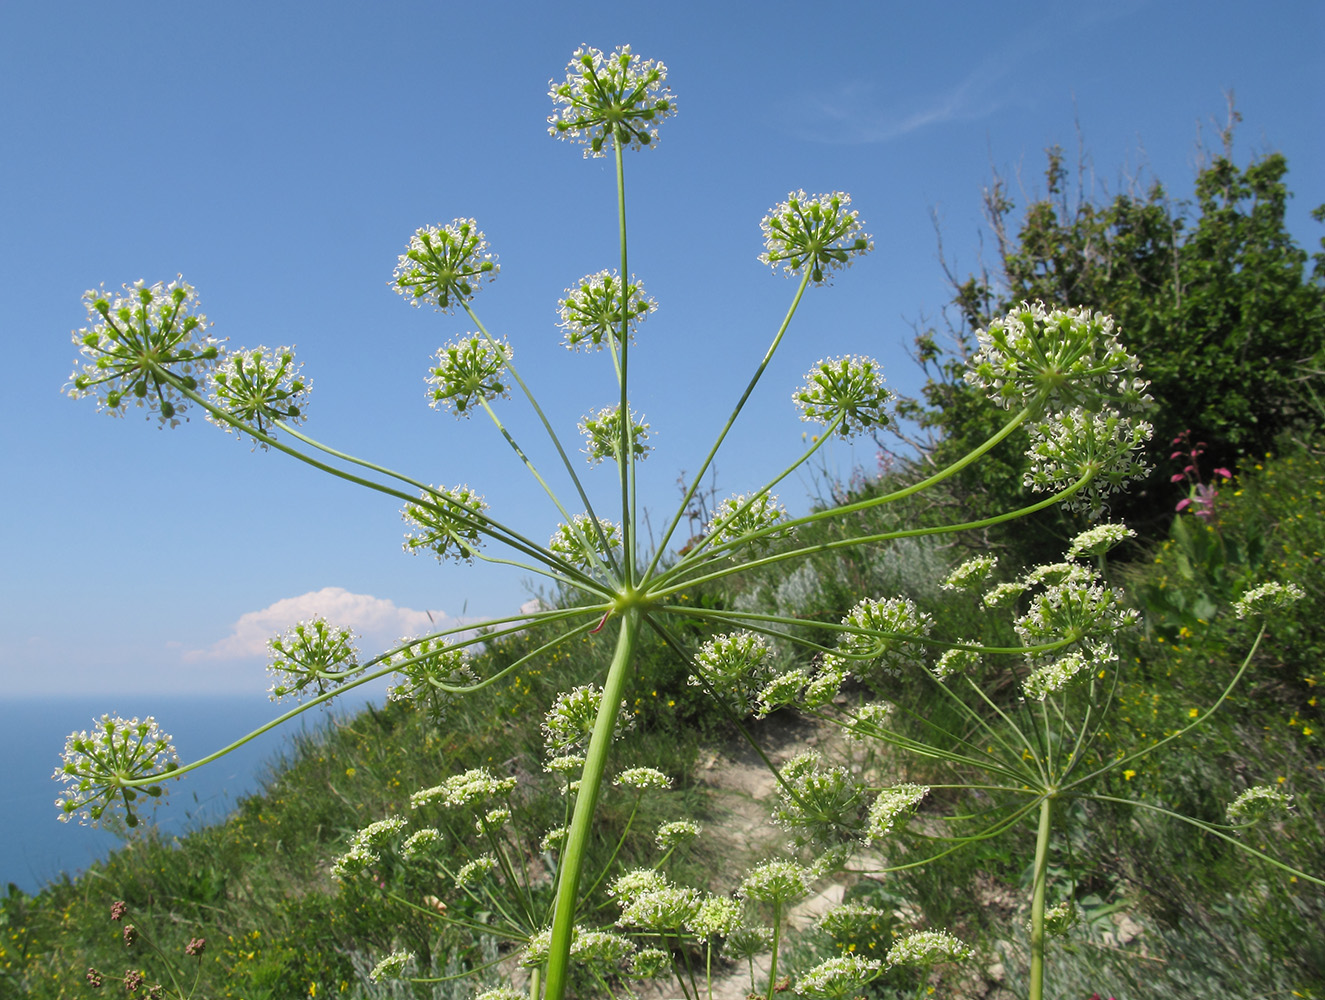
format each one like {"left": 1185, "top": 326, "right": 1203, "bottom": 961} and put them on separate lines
{"left": 184, "top": 587, "right": 447, "bottom": 661}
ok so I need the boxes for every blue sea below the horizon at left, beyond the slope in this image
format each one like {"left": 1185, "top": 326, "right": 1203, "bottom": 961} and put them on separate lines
{"left": 0, "top": 695, "right": 378, "bottom": 893}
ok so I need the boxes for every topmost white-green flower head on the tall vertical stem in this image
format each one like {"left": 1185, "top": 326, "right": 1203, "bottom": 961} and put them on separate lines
{"left": 547, "top": 45, "right": 676, "bottom": 156}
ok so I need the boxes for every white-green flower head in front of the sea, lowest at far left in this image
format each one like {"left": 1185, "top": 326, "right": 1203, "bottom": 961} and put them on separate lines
{"left": 52, "top": 715, "right": 179, "bottom": 826}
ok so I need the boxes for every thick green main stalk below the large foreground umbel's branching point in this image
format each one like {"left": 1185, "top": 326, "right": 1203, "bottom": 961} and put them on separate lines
{"left": 546, "top": 608, "right": 641, "bottom": 1000}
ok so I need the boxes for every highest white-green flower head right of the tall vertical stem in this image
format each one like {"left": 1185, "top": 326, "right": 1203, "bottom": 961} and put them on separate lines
{"left": 759, "top": 191, "right": 875, "bottom": 285}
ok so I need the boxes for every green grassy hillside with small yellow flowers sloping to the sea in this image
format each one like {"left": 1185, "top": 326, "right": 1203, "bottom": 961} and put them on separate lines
{"left": 0, "top": 446, "right": 1325, "bottom": 1000}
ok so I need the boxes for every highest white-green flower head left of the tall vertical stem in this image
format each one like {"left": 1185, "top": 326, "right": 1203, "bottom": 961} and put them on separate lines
{"left": 391, "top": 219, "right": 501, "bottom": 313}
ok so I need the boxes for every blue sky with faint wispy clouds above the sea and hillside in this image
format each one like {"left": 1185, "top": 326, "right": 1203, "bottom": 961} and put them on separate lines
{"left": 0, "top": 0, "right": 1325, "bottom": 699}
